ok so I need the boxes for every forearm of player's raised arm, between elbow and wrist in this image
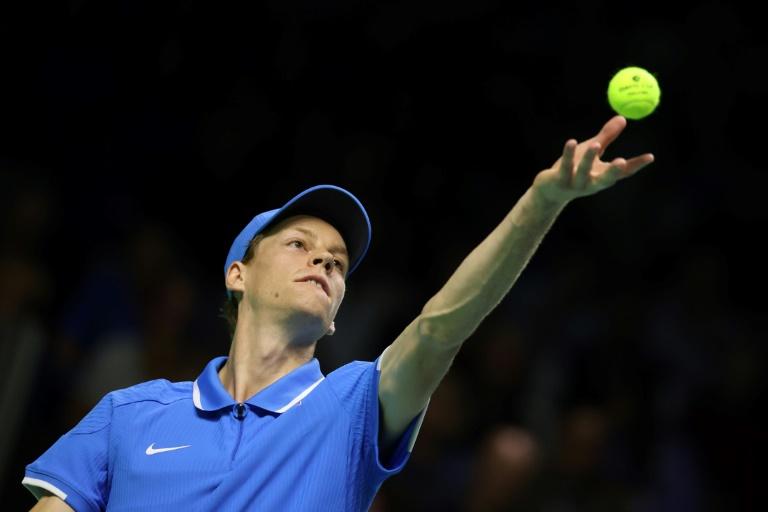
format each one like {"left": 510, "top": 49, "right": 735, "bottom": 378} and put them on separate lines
{"left": 421, "top": 188, "right": 567, "bottom": 344}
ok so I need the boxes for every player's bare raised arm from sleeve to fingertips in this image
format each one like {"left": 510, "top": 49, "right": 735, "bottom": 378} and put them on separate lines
{"left": 379, "top": 116, "right": 653, "bottom": 447}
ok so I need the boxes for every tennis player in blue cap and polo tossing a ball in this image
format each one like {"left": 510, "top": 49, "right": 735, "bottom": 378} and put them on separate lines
{"left": 23, "top": 116, "right": 653, "bottom": 511}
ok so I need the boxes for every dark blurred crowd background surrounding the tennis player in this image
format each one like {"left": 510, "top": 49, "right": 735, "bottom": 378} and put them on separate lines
{"left": 0, "top": 0, "right": 768, "bottom": 512}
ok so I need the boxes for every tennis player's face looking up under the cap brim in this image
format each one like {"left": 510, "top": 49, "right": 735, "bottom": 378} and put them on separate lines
{"left": 228, "top": 215, "right": 349, "bottom": 332}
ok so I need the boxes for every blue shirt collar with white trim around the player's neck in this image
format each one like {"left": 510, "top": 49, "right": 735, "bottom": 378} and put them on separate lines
{"left": 192, "top": 356, "right": 325, "bottom": 414}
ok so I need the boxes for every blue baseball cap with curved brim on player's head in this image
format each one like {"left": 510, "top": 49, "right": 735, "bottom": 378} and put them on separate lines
{"left": 224, "top": 185, "right": 371, "bottom": 288}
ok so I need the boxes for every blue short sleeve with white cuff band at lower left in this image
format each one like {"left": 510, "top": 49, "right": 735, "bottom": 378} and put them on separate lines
{"left": 22, "top": 395, "right": 112, "bottom": 512}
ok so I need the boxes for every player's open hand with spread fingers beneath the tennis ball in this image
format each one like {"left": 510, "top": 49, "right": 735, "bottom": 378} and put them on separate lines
{"left": 533, "top": 116, "right": 654, "bottom": 203}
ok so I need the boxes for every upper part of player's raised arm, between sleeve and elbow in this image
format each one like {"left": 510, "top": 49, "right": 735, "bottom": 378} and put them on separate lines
{"left": 379, "top": 316, "right": 461, "bottom": 443}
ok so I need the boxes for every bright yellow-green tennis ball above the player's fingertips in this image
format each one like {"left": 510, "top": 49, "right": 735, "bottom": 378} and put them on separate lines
{"left": 608, "top": 66, "right": 661, "bottom": 119}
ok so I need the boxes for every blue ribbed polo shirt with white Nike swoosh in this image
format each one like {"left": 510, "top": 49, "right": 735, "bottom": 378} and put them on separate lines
{"left": 22, "top": 348, "right": 426, "bottom": 512}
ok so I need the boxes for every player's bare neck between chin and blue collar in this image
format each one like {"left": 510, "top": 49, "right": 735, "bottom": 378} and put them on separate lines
{"left": 219, "top": 319, "right": 317, "bottom": 403}
